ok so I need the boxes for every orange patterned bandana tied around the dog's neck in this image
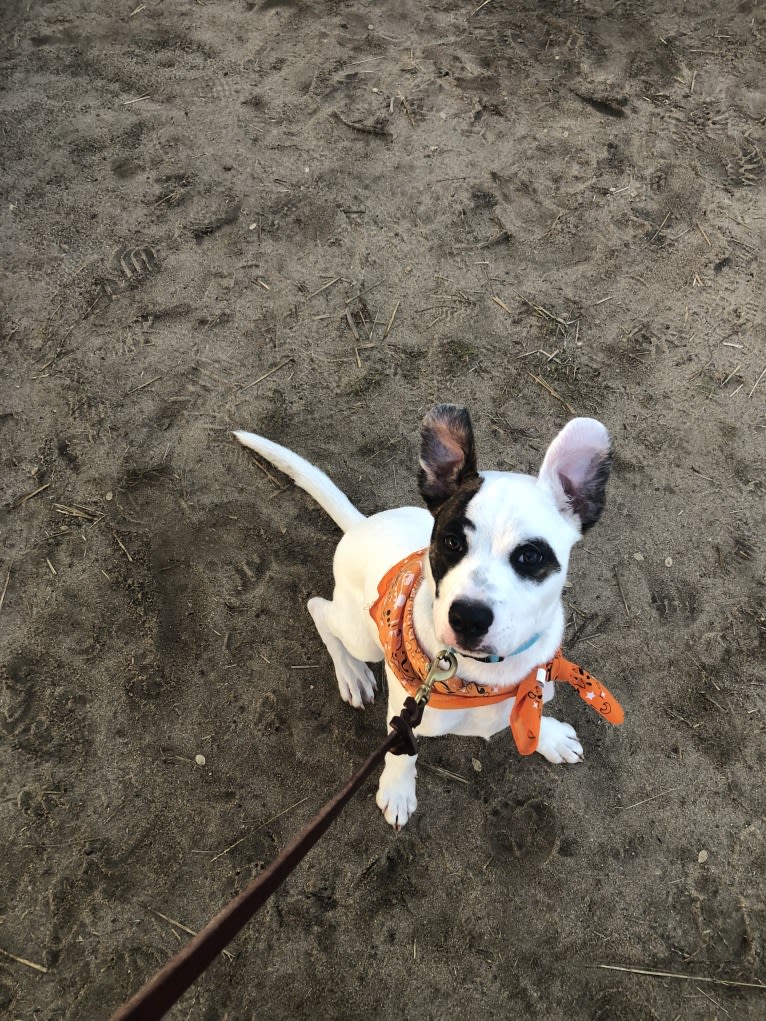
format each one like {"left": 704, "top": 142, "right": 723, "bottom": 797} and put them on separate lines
{"left": 370, "top": 549, "right": 624, "bottom": 756}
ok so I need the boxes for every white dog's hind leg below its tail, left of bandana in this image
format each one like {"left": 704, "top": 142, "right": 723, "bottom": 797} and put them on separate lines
{"left": 308, "top": 588, "right": 382, "bottom": 709}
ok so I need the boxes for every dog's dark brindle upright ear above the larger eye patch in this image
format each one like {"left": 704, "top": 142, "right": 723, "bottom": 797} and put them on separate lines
{"left": 418, "top": 404, "right": 477, "bottom": 514}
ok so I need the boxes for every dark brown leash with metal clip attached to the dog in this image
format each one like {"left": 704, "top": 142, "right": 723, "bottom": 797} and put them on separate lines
{"left": 110, "top": 652, "right": 457, "bottom": 1021}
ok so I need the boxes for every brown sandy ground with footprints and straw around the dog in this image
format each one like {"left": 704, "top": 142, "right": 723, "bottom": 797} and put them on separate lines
{"left": 0, "top": 0, "right": 766, "bottom": 1021}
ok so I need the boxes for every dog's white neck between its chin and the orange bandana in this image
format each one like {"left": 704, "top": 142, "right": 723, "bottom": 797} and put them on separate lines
{"left": 413, "top": 551, "right": 564, "bottom": 687}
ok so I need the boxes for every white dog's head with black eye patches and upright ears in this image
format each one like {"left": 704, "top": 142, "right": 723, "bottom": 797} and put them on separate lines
{"left": 418, "top": 404, "right": 612, "bottom": 658}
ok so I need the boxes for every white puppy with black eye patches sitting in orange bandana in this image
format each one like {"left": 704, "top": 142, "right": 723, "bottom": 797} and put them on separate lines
{"left": 234, "top": 404, "right": 622, "bottom": 830}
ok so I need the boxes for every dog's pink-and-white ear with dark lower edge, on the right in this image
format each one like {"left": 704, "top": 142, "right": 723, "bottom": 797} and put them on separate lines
{"left": 539, "top": 419, "right": 612, "bottom": 532}
